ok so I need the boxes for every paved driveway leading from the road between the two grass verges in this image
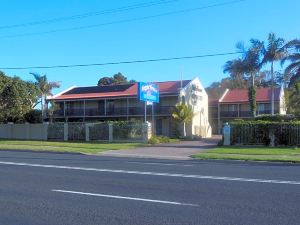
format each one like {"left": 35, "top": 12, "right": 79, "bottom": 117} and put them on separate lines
{"left": 100, "top": 136, "right": 221, "bottom": 160}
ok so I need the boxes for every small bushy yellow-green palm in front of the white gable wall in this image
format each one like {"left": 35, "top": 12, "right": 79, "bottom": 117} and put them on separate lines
{"left": 172, "top": 103, "right": 195, "bottom": 137}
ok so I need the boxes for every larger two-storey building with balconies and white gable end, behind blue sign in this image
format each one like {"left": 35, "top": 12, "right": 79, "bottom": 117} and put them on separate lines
{"left": 48, "top": 78, "right": 211, "bottom": 137}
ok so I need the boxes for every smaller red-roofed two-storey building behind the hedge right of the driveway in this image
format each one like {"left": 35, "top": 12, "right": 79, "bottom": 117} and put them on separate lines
{"left": 209, "top": 88, "right": 286, "bottom": 133}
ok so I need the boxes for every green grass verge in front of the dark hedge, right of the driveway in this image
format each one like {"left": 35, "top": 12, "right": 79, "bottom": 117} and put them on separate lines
{"left": 193, "top": 146, "right": 300, "bottom": 162}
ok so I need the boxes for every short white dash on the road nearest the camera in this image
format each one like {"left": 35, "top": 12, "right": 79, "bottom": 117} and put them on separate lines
{"left": 52, "top": 189, "right": 199, "bottom": 206}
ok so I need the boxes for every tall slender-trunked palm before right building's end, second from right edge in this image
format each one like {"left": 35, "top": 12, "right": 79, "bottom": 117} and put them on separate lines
{"left": 262, "top": 33, "right": 286, "bottom": 115}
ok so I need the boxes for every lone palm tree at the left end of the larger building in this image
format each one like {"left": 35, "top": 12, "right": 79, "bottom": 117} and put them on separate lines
{"left": 30, "top": 73, "right": 60, "bottom": 120}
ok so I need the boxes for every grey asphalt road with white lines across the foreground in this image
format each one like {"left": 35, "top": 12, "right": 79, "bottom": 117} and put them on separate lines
{"left": 0, "top": 151, "right": 300, "bottom": 225}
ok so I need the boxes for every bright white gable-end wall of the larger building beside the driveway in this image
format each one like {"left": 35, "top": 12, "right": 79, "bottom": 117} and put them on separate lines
{"left": 180, "top": 77, "right": 211, "bottom": 137}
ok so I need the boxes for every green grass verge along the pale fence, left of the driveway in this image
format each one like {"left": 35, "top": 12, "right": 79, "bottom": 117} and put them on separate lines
{"left": 0, "top": 140, "right": 146, "bottom": 153}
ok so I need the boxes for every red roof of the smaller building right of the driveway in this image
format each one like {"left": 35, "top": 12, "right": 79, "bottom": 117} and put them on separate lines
{"left": 221, "top": 88, "right": 280, "bottom": 103}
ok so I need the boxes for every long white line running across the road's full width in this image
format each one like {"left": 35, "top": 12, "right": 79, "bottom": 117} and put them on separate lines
{"left": 0, "top": 161, "right": 300, "bottom": 185}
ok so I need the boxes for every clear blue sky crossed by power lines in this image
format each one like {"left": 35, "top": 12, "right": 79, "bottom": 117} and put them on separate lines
{"left": 0, "top": 0, "right": 300, "bottom": 93}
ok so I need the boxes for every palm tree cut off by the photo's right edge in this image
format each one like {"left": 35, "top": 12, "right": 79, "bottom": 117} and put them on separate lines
{"left": 281, "top": 39, "right": 300, "bottom": 87}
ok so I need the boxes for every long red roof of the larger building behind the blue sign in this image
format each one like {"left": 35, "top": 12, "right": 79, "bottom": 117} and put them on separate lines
{"left": 49, "top": 80, "right": 190, "bottom": 100}
